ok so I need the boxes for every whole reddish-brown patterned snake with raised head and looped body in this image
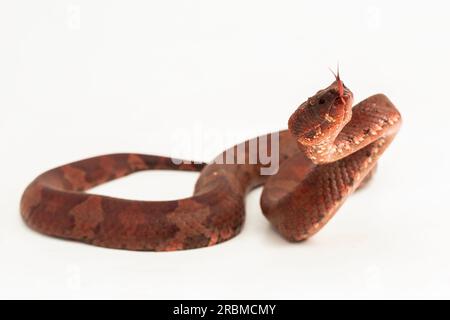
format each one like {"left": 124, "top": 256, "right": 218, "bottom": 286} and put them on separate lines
{"left": 20, "top": 73, "right": 401, "bottom": 251}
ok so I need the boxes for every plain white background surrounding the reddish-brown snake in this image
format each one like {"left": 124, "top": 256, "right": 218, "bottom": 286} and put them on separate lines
{"left": 0, "top": 0, "right": 450, "bottom": 299}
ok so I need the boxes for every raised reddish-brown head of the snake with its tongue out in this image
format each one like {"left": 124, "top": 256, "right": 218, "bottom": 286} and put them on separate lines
{"left": 289, "top": 79, "right": 353, "bottom": 146}
